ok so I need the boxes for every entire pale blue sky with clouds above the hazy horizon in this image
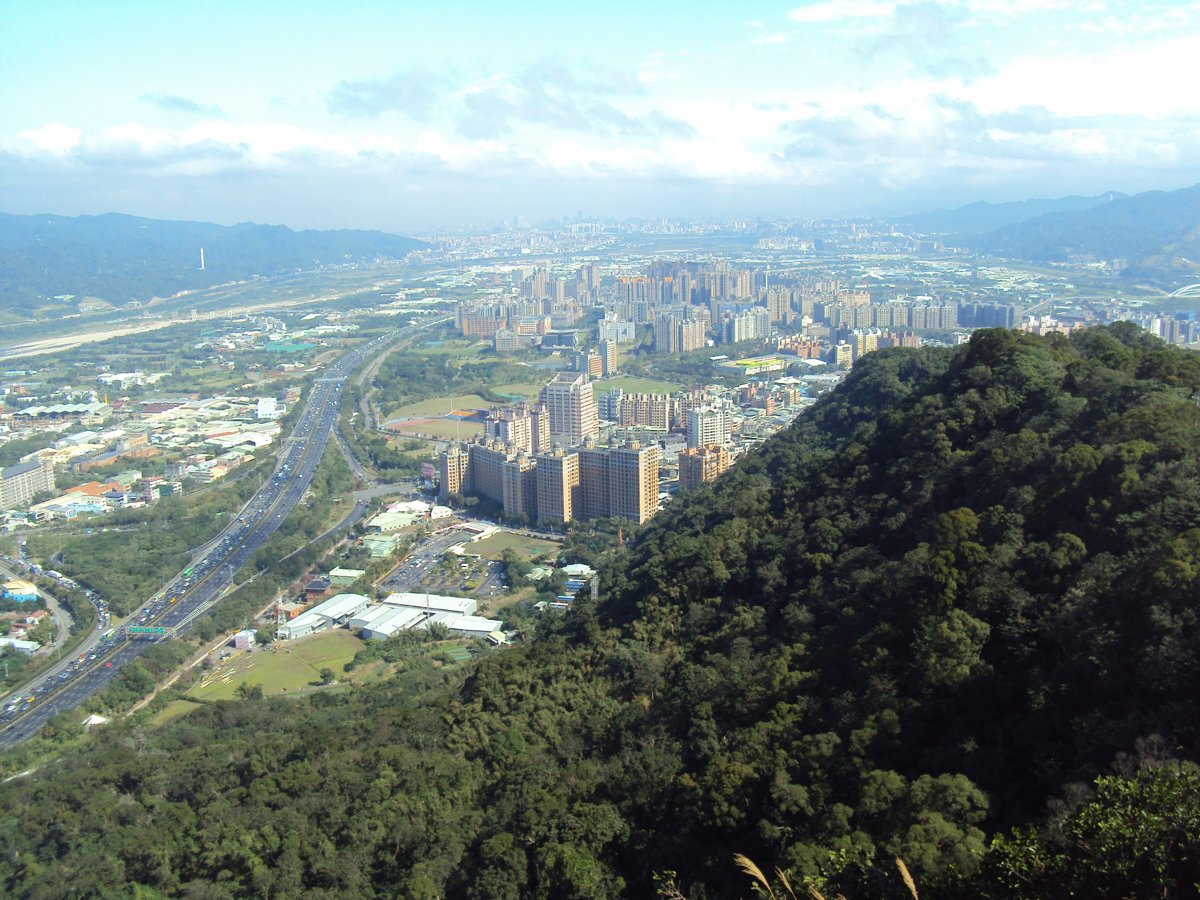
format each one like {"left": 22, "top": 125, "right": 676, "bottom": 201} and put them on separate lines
{"left": 0, "top": 0, "right": 1200, "bottom": 232}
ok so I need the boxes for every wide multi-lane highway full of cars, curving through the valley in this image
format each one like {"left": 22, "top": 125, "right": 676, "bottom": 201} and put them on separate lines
{"left": 0, "top": 325, "right": 412, "bottom": 749}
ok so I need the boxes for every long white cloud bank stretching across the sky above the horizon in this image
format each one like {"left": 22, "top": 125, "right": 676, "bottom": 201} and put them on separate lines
{"left": 0, "top": 12, "right": 1200, "bottom": 229}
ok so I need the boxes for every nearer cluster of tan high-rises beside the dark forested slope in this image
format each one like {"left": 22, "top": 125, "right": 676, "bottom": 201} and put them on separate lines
{"left": 438, "top": 357, "right": 800, "bottom": 526}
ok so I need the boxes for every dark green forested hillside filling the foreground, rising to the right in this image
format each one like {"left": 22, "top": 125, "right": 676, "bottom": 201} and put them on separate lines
{"left": 0, "top": 325, "right": 1200, "bottom": 898}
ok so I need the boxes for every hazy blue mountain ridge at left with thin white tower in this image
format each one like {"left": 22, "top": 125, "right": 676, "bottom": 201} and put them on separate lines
{"left": 0, "top": 212, "right": 427, "bottom": 316}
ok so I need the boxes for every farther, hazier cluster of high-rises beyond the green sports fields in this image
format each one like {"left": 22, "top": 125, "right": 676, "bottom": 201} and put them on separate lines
{"left": 456, "top": 254, "right": 993, "bottom": 374}
